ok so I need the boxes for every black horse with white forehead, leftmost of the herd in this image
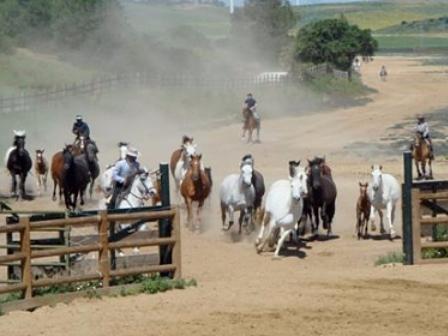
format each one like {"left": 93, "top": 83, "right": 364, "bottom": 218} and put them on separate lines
{"left": 5, "top": 131, "right": 33, "bottom": 199}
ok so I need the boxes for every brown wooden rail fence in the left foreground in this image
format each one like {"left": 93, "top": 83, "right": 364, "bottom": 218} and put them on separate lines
{"left": 0, "top": 207, "right": 181, "bottom": 307}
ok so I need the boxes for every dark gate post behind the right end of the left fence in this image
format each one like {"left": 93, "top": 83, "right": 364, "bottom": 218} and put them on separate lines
{"left": 159, "top": 162, "right": 174, "bottom": 278}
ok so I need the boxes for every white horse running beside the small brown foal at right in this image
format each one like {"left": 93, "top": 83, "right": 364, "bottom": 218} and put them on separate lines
{"left": 368, "top": 166, "right": 401, "bottom": 239}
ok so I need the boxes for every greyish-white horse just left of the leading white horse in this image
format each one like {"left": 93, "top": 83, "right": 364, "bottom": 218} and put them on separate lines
{"left": 219, "top": 161, "right": 255, "bottom": 233}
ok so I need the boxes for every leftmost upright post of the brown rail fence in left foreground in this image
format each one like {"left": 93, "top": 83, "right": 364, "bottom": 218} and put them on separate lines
{"left": 19, "top": 216, "right": 33, "bottom": 299}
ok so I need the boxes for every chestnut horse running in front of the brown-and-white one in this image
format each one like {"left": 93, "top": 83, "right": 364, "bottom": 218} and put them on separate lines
{"left": 180, "top": 154, "right": 211, "bottom": 232}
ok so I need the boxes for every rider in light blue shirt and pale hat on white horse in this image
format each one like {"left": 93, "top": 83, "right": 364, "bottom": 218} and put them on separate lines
{"left": 108, "top": 148, "right": 140, "bottom": 209}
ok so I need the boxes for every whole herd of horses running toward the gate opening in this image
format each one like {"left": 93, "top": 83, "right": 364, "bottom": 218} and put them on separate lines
{"left": 0, "top": 122, "right": 432, "bottom": 257}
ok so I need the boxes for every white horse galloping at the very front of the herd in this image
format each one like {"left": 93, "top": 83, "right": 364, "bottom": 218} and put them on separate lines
{"left": 255, "top": 161, "right": 308, "bottom": 259}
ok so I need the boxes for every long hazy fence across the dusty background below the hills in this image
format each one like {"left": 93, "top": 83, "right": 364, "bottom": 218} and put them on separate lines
{"left": 0, "top": 64, "right": 348, "bottom": 114}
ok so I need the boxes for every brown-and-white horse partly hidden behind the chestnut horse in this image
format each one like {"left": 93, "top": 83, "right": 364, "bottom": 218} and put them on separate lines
{"left": 170, "top": 135, "right": 197, "bottom": 202}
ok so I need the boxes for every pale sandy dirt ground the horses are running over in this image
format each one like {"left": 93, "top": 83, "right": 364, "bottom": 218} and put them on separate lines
{"left": 0, "top": 57, "right": 448, "bottom": 336}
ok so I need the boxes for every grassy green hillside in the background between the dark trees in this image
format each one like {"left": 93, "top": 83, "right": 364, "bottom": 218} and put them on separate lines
{"left": 0, "top": 0, "right": 448, "bottom": 96}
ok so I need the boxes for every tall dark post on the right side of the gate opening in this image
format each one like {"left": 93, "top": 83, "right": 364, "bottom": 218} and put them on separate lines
{"left": 402, "top": 151, "right": 414, "bottom": 265}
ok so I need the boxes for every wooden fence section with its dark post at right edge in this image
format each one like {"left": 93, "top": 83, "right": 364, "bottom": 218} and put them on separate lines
{"left": 402, "top": 151, "right": 448, "bottom": 265}
